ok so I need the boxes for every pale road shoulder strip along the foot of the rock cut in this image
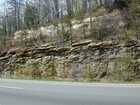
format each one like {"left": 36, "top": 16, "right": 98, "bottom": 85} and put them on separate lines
{"left": 0, "top": 79, "right": 140, "bottom": 88}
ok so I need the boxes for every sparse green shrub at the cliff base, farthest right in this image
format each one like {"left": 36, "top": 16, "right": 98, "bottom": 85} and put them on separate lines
{"left": 109, "top": 55, "right": 135, "bottom": 82}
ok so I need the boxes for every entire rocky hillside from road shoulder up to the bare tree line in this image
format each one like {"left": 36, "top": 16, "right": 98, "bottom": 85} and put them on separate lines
{"left": 0, "top": 2, "right": 140, "bottom": 82}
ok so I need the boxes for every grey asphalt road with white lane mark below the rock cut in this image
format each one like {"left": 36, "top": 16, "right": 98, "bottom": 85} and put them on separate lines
{"left": 0, "top": 79, "right": 140, "bottom": 105}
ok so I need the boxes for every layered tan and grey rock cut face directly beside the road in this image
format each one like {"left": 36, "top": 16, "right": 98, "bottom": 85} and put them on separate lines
{"left": 0, "top": 40, "right": 140, "bottom": 80}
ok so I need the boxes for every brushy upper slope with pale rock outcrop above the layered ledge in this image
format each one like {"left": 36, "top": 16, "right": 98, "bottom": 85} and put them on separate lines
{"left": 0, "top": 0, "right": 140, "bottom": 49}
